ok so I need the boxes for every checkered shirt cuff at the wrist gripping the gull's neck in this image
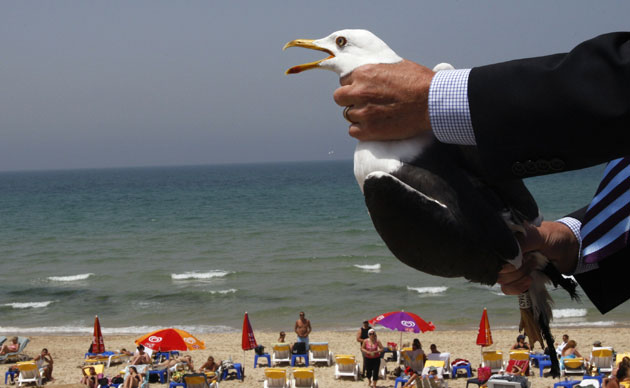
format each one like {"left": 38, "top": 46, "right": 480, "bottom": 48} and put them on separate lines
{"left": 429, "top": 69, "right": 477, "bottom": 145}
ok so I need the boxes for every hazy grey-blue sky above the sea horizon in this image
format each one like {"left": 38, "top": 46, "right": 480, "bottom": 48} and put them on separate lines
{"left": 0, "top": 0, "right": 630, "bottom": 171}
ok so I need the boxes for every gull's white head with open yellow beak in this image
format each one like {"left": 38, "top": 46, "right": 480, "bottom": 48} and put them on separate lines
{"left": 283, "top": 30, "right": 402, "bottom": 77}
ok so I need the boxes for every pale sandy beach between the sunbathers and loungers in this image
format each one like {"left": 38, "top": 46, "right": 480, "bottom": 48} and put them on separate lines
{"left": 0, "top": 328, "right": 630, "bottom": 388}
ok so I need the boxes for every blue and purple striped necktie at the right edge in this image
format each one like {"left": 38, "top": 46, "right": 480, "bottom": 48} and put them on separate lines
{"left": 580, "top": 157, "right": 630, "bottom": 264}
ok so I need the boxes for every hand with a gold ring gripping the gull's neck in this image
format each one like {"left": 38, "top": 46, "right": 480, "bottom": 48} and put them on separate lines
{"left": 333, "top": 60, "right": 435, "bottom": 140}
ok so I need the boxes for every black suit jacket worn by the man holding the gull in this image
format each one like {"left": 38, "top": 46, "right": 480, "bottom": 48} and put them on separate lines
{"left": 468, "top": 32, "right": 630, "bottom": 313}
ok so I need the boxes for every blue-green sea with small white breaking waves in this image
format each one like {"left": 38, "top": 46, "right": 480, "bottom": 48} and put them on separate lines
{"left": 0, "top": 161, "right": 630, "bottom": 335}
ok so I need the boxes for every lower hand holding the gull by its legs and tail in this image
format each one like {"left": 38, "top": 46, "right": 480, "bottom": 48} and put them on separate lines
{"left": 497, "top": 221, "right": 580, "bottom": 295}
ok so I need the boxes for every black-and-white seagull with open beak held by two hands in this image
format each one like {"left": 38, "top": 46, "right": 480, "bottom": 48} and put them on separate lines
{"left": 283, "top": 29, "right": 577, "bottom": 374}
